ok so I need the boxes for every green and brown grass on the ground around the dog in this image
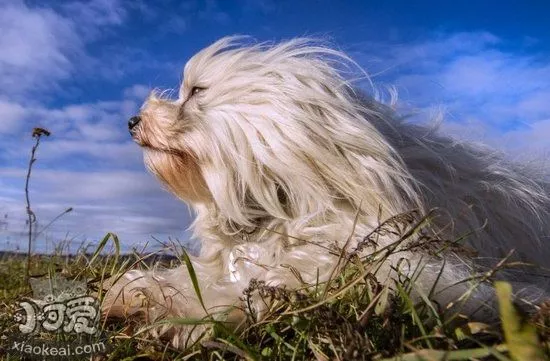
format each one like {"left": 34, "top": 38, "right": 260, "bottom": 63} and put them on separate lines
{"left": 0, "top": 218, "right": 550, "bottom": 361}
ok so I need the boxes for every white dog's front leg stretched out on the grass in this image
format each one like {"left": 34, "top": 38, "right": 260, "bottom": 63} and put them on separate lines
{"left": 102, "top": 258, "right": 248, "bottom": 348}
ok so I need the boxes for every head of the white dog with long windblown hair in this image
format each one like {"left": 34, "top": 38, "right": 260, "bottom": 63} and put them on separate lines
{"left": 129, "top": 38, "right": 418, "bottom": 226}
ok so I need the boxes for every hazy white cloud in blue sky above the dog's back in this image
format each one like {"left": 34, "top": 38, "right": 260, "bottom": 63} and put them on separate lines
{"left": 355, "top": 32, "right": 550, "bottom": 154}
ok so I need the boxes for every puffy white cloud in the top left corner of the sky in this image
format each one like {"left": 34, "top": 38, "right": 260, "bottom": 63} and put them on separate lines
{"left": 0, "top": 0, "right": 126, "bottom": 98}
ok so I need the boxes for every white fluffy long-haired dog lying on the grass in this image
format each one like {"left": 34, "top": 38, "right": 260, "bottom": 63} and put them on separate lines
{"left": 104, "top": 38, "right": 550, "bottom": 347}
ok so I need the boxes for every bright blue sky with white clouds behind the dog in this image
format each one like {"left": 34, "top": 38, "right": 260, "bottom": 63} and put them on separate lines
{"left": 0, "top": 0, "right": 550, "bottom": 250}
